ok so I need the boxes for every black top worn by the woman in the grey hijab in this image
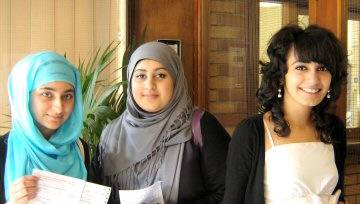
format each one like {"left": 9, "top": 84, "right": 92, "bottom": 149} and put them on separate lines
{"left": 90, "top": 112, "right": 230, "bottom": 204}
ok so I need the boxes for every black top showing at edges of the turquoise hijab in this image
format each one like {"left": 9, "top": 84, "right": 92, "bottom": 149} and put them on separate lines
{"left": 0, "top": 133, "right": 90, "bottom": 204}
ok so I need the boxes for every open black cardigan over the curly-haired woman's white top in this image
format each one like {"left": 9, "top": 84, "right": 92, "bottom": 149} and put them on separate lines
{"left": 223, "top": 115, "right": 346, "bottom": 204}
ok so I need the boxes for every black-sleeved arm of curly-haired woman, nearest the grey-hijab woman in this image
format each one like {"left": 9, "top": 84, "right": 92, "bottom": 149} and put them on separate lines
{"left": 223, "top": 120, "right": 256, "bottom": 204}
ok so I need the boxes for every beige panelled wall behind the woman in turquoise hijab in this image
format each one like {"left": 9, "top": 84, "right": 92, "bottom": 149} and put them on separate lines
{"left": 0, "top": 0, "right": 119, "bottom": 134}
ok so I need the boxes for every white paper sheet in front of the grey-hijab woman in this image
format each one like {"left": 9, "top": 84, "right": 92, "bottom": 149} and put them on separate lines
{"left": 119, "top": 181, "right": 164, "bottom": 204}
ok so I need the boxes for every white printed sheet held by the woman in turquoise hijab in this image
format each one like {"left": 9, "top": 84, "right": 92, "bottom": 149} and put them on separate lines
{"left": 29, "top": 169, "right": 111, "bottom": 204}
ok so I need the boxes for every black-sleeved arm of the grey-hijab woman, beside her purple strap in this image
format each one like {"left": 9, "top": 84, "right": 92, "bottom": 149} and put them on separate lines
{"left": 192, "top": 112, "right": 231, "bottom": 203}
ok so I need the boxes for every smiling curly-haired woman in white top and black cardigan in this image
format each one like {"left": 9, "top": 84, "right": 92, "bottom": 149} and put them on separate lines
{"left": 223, "top": 25, "right": 348, "bottom": 204}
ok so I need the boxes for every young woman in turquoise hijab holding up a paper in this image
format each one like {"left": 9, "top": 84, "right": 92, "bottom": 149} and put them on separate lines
{"left": 0, "top": 51, "right": 89, "bottom": 203}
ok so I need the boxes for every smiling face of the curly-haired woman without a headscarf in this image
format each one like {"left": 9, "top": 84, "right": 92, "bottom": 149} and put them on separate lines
{"left": 284, "top": 48, "right": 331, "bottom": 109}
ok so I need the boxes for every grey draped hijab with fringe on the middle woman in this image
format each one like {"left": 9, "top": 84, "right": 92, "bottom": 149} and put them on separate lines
{"left": 100, "top": 42, "right": 193, "bottom": 203}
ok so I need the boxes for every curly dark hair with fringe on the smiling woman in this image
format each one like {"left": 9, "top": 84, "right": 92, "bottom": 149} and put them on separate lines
{"left": 256, "top": 25, "right": 348, "bottom": 143}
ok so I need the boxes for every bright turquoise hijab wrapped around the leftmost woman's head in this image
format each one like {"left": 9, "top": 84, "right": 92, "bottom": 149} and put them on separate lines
{"left": 4, "top": 51, "right": 87, "bottom": 199}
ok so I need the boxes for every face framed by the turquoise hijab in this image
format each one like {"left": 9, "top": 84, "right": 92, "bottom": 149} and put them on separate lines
{"left": 31, "top": 81, "right": 75, "bottom": 139}
